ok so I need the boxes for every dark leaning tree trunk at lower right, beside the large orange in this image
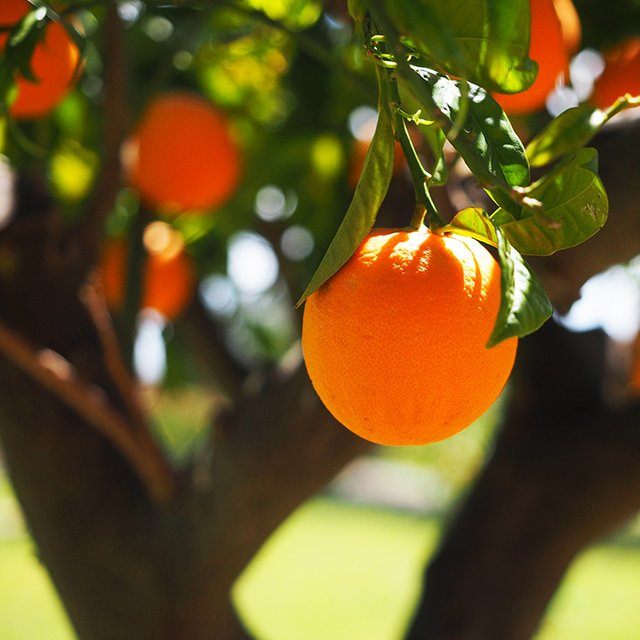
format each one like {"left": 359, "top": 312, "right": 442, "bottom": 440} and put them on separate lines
{"left": 407, "top": 323, "right": 640, "bottom": 640}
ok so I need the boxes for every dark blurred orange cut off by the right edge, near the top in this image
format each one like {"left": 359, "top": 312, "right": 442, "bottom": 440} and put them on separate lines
{"left": 591, "top": 37, "right": 640, "bottom": 109}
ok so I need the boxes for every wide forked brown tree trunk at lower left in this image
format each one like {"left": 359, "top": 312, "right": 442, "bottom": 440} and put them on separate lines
{"left": 0, "top": 189, "right": 368, "bottom": 640}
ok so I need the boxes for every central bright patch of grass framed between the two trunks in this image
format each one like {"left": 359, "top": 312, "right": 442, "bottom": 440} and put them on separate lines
{"left": 235, "top": 500, "right": 437, "bottom": 640}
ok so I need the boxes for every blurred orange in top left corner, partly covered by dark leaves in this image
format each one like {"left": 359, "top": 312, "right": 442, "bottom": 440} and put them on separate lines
{"left": 0, "top": 0, "right": 80, "bottom": 119}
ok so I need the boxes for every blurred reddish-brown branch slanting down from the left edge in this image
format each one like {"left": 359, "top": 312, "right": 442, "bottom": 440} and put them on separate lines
{"left": 0, "top": 322, "right": 173, "bottom": 502}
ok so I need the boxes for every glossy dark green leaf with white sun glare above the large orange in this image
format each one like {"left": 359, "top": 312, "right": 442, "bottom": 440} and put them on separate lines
{"left": 399, "top": 67, "right": 529, "bottom": 209}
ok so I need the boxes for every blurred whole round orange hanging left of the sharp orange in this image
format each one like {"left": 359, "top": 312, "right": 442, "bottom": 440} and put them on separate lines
{"left": 124, "top": 92, "right": 241, "bottom": 214}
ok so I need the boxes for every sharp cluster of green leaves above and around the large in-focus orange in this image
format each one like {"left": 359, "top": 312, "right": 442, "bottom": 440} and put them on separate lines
{"left": 300, "top": 0, "right": 608, "bottom": 345}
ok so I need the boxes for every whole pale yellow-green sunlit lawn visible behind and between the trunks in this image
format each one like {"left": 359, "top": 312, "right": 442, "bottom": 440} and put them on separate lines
{"left": 0, "top": 482, "right": 640, "bottom": 640}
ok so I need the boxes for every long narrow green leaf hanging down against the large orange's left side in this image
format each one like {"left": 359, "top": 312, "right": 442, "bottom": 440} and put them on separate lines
{"left": 296, "top": 75, "right": 395, "bottom": 307}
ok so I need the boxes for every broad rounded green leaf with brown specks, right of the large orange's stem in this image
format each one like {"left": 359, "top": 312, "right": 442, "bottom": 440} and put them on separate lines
{"left": 492, "top": 148, "right": 608, "bottom": 255}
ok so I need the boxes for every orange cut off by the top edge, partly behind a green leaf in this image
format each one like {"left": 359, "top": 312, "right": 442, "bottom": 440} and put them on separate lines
{"left": 494, "top": 0, "right": 581, "bottom": 115}
